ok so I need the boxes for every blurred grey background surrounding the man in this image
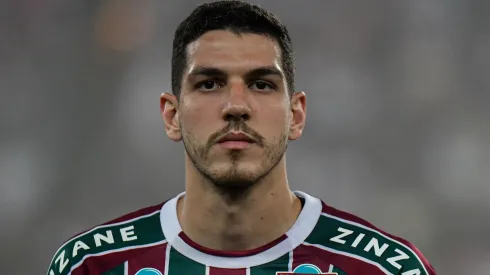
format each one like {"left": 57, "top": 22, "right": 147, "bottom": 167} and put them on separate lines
{"left": 0, "top": 0, "right": 490, "bottom": 275}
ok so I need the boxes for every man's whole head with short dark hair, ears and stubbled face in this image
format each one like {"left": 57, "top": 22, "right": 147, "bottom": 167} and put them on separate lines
{"left": 161, "top": 1, "right": 306, "bottom": 186}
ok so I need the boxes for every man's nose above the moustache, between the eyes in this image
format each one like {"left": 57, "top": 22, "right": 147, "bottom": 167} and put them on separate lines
{"left": 222, "top": 83, "right": 252, "bottom": 121}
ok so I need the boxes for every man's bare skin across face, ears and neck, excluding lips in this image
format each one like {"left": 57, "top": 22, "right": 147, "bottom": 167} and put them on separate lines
{"left": 160, "top": 31, "right": 306, "bottom": 251}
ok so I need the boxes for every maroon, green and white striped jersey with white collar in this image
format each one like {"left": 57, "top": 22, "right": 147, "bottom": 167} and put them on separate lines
{"left": 47, "top": 191, "right": 436, "bottom": 275}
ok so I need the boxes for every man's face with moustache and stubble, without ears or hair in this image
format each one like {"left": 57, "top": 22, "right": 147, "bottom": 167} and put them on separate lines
{"left": 168, "top": 31, "right": 300, "bottom": 186}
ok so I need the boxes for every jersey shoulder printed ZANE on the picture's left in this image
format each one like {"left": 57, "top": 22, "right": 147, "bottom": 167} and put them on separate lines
{"left": 48, "top": 203, "right": 165, "bottom": 275}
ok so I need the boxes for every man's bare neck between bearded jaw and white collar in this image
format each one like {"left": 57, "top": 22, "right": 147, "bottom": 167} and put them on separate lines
{"left": 177, "top": 158, "right": 301, "bottom": 251}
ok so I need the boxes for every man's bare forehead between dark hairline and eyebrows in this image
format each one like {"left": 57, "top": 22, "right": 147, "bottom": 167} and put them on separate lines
{"left": 187, "top": 30, "right": 282, "bottom": 71}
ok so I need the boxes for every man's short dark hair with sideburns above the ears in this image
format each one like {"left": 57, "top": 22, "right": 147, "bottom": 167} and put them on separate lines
{"left": 172, "top": 0, "right": 294, "bottom": 97}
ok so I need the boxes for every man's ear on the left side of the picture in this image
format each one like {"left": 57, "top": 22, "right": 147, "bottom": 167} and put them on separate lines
{"left": 160, "top": 93, "right": 182, "bottom": 141}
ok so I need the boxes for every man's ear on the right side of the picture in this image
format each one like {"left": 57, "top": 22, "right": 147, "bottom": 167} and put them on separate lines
{"left": 289, "top": 92, "right": 306, "bottom": 140}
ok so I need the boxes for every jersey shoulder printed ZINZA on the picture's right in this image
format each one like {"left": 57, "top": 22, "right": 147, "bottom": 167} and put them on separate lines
{"left": 306, "top": 203, "right": 436, "bottom": 275}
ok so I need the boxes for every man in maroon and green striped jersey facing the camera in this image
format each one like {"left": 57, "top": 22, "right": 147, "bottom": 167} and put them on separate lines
{"left": 48, "top": 1, "right": 435, "bottom": 275}
